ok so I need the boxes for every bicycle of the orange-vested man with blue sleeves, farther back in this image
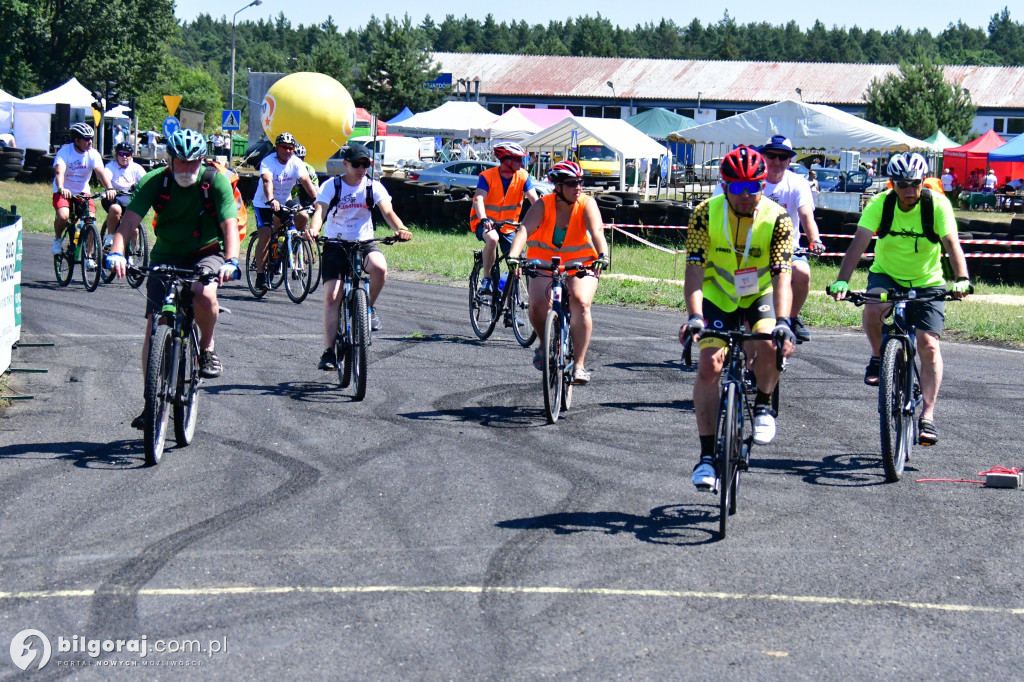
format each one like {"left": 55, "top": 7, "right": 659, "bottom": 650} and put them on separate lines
{"left": 469, "top": 220, "right": 537, "bottom": 348}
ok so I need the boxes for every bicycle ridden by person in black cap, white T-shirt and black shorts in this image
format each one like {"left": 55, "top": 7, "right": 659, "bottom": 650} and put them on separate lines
{"left": 317, "top": 237, "right": 398, "bottom": 400}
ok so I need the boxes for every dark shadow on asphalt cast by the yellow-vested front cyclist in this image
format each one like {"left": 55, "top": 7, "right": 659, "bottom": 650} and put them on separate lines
{"left": 495, "top": 505, "right": 718, "bottom": 546}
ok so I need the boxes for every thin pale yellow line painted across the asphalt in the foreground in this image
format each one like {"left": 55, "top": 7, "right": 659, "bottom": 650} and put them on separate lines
{"left": 0, "top": 585, "right": 1024, "bottom": 615}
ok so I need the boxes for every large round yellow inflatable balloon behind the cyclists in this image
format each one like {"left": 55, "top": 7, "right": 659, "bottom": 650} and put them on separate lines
{"left": 260, "top": 72, "right": 355, "bottom": 172}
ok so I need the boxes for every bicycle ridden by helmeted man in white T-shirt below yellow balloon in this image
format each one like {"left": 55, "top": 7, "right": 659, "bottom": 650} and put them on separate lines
{"left": 246, "top": 205, "right": 318, "bottom": 303}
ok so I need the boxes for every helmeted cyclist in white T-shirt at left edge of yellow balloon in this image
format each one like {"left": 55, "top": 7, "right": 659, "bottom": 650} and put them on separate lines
{"left": 253, "top": 132, "right": 316, "bottom": 290}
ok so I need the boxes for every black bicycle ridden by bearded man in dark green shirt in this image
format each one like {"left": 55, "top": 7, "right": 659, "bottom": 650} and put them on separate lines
{"left": 128, "top": 265, "right": 217, "bottom": 465}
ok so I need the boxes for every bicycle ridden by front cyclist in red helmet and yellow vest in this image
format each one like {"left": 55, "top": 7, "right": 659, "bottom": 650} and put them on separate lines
{"left": 701, "top": 330, "right": 783, "bottom": 538}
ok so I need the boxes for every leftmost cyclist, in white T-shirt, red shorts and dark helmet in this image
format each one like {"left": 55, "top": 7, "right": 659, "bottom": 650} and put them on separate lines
{"left": 52, "top": 123, "right": 116, "bottom": 260}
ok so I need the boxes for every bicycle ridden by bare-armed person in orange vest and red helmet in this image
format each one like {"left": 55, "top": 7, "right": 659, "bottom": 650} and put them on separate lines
{"left": 522, "top": 256, "right": 597, "bottom": 424}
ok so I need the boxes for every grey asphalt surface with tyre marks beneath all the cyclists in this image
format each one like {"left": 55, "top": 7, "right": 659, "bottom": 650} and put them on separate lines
{"left": 0, "top": 235, "right": 1024, "bottom": 680}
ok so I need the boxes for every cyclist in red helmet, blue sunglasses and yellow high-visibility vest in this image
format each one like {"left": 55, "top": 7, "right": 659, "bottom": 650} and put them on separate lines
{"left": 679, "top": 146, "right": 797, "bottom": 491}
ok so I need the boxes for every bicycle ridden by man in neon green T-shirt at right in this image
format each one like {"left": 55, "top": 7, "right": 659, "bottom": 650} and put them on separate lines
{"left": 844, "top": 288, "right": 957, "bottom": 483}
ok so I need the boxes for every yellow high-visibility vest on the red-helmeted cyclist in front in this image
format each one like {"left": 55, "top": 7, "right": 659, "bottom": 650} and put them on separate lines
{"left": 703, "top": 195, "right": 787, "bottom": 312}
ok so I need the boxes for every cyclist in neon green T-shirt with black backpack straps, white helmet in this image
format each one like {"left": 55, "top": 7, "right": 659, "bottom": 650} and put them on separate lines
{"left": 827, "top": 152, "right": 971, "bottom": 445}
